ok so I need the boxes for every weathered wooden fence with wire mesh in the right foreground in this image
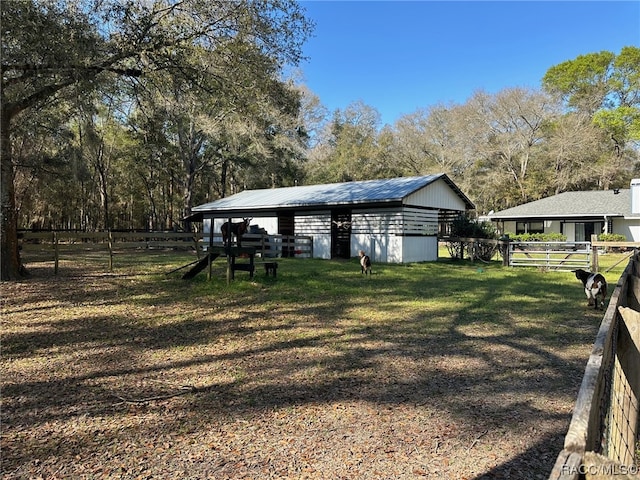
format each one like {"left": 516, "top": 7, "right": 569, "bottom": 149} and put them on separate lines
{"left": 549, "top": 251, "right": 640, "bottom": 480}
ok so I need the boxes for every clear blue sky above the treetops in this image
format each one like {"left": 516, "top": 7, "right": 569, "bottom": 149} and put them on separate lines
{"left": 301, "top": 0, "right": 640, "bottom": 125}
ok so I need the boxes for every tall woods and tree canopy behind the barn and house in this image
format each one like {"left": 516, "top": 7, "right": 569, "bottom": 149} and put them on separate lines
{"left": 0, "top": 0, "right": 640, "bottom": 279}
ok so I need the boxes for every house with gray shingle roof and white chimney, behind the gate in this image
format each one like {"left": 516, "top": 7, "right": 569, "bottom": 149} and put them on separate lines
{"left": 487, "top": 179, "right": 640, "bottom": 242}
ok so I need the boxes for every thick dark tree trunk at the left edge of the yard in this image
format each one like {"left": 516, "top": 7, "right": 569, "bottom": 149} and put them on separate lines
{"left": 0, "top": 110, "right": 24, "bottom": 281}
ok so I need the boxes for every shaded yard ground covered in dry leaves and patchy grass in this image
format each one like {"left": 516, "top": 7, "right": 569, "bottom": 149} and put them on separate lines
{"left": 0, "top": 256, "right": 624, "bottom": 479}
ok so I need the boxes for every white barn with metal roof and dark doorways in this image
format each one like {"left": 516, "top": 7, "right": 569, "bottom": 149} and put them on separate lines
{"left": 190, "top": 174, "right": 475, "bottom": 263}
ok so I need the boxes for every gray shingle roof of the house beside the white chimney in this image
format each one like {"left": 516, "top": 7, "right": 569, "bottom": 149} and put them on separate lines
{"left": 490, "top": 189, "right": 632, "bottom": 219}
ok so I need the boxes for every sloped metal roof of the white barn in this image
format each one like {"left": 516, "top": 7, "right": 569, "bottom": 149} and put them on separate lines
{"left": 192, "top": 173, "right": 475, "bottom": 215}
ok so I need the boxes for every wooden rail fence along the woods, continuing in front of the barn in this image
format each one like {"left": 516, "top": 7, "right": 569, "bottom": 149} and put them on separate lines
{"left": 19, "top": 231, "right": 313, "bottom": 274}
